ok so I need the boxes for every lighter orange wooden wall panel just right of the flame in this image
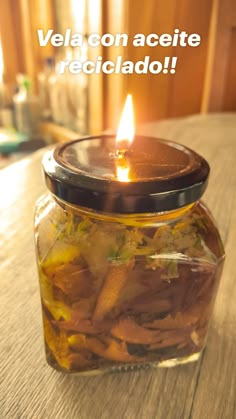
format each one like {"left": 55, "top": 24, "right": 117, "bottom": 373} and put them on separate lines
{"left": 125, "top": 0, "right": 179, "bottom": 123}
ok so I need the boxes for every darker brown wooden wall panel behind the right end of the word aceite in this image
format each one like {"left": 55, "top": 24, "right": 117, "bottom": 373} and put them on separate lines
{"left": 169, "top": 0, "right": 212, "bottom": 117}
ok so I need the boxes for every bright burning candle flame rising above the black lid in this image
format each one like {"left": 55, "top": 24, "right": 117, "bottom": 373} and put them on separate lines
{"left": 116, "top": 95, "right": 134, "bottom": 150}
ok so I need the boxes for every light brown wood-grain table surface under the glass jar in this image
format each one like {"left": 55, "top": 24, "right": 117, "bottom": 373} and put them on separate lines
{"left": 0, "top": 114, "right": 236, "bottom": 419}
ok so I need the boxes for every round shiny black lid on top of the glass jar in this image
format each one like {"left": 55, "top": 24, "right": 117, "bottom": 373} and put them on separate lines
{"left": 43, "top": 135, "right": 210, "bottom": 214}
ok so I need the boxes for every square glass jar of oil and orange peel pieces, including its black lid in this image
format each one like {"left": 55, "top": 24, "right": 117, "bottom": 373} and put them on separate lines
{"left": 35, "top": 136, "right": 224, "bottom": 374}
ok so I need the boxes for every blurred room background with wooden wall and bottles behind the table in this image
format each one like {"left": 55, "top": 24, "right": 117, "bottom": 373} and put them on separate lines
{"left": 0, "top": 0, "right": 236, "bottom": 167}
